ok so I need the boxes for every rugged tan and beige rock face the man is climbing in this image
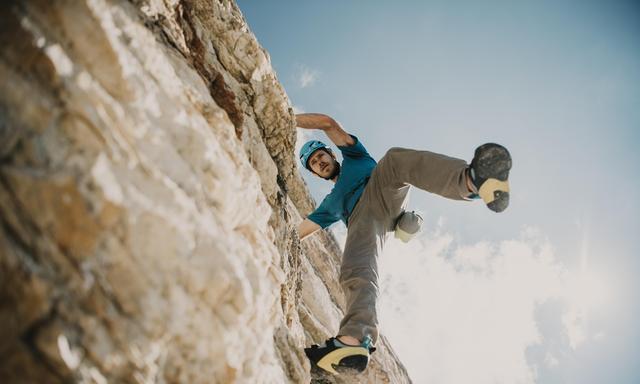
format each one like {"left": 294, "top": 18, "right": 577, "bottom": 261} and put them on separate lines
{"left": 0, "top": 0, "right": 409, "bottom": 384}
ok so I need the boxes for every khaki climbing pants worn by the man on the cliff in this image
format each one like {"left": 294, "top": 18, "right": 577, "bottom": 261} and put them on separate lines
{"left": 338, "top": 148, "right": 470, "bottom": 342}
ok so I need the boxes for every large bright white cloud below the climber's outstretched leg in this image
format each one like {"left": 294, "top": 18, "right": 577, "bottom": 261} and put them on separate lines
{"left": 380, "top": 229, "right": 608, "bottom": 384}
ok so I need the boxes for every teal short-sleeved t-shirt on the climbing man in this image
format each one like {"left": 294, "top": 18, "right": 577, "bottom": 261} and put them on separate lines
{"left": 307, "top": 135, "right": 376, "bottom": 228}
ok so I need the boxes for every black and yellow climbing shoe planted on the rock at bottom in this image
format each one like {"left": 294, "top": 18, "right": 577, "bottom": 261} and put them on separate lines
{"left": 304, "top": 336, "right": 376, "bottom": 375}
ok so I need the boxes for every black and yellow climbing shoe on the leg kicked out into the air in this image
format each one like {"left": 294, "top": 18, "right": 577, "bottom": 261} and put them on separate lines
{"left": 469, "top": 143, "right": 511, "bottom": 212}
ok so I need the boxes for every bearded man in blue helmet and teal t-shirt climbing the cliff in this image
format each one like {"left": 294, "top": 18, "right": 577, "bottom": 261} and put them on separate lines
{"left": 296, "top": 113, "right": 511, "bottom": 374}
